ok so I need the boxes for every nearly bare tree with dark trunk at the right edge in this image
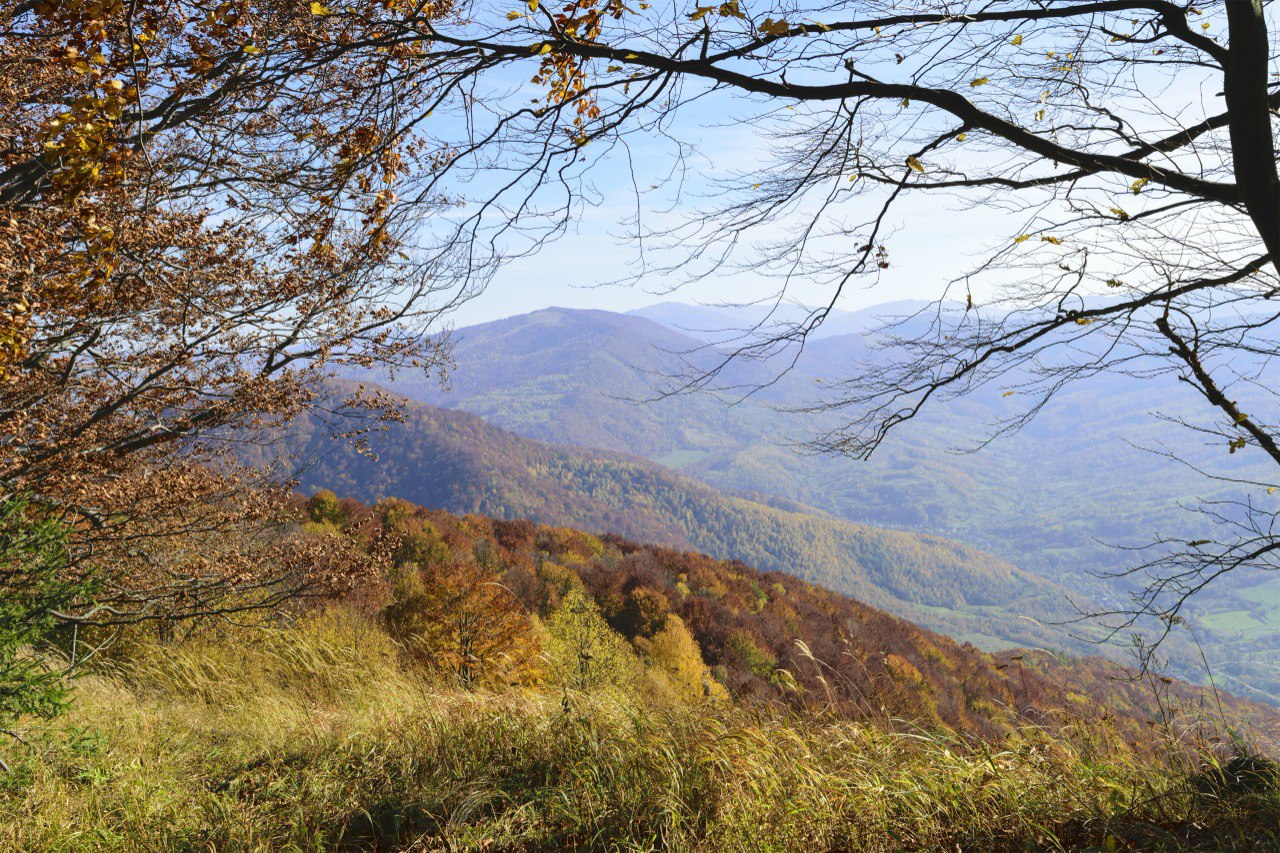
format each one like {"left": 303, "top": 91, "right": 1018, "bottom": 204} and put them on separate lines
{"left": 307, "top": 0, "right": 1280, "bottom": 650}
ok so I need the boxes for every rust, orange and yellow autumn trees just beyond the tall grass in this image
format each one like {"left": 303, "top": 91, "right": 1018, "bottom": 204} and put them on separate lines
{"left": 293, "top": 492, "right": 1270, "bottom": 743}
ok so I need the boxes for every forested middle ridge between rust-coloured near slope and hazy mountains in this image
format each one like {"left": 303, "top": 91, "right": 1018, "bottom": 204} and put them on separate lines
{"left": 264, "top": 379, "right": 1085, "bottom": 647}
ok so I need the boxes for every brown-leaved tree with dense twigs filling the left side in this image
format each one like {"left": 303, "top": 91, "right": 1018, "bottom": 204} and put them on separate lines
{"left": 0, "top": 0, "right": 479, "bottom": 620}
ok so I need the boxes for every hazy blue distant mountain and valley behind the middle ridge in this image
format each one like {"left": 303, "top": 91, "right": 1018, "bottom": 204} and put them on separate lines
{"left": 368, "top": 306, "right": 1249, "bottom": 578}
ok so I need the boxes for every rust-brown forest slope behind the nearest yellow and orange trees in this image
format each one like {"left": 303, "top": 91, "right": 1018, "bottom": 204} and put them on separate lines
{"left": 317, "top": 491, "right": 1275, "bottom": 739}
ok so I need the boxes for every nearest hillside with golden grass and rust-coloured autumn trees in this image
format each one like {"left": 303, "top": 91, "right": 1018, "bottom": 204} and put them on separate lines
{"left": 0, "top": 491, "right": 1277, "bottom": 853}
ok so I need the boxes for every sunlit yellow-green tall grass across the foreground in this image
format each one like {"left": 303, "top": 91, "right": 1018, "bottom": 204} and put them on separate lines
{"left": 0, "top": 612, "right": 1280, "bottom": 850}
